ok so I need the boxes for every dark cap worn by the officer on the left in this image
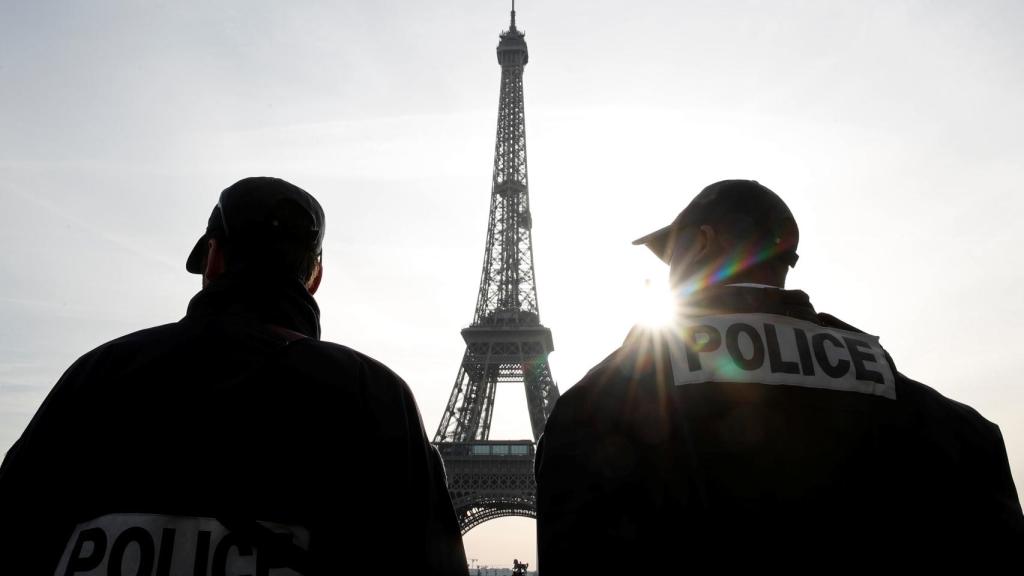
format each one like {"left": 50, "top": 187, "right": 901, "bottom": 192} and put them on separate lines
{"left": 185, "top": 176, "right": 324, "bottom": 274}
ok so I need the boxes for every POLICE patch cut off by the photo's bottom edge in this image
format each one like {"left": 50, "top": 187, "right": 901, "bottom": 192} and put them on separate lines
{"left": 54, "top": 513, "right": 309, "bottom": 576}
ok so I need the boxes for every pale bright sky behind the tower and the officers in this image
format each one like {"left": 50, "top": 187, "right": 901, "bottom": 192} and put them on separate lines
{"left": 0, "top": 0, "right": 1024, "bottom": 566}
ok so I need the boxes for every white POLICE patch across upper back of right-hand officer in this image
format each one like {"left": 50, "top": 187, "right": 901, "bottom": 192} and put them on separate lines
{"left": 670, "top": 314, "right": 896, "bottom": 400}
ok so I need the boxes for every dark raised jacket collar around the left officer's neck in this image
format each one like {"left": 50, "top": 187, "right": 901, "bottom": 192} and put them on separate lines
{"left": 185, "top": 272, "right": 321, "bottom": 340}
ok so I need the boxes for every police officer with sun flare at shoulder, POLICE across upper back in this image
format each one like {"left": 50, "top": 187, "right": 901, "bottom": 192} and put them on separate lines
{"left": 537, "top": 180, "right": 1024, "bottom": 576}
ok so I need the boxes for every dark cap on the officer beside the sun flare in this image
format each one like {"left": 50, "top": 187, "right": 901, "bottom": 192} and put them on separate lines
{"left": 633, "top": 180, "right": 800, "bottom": 266}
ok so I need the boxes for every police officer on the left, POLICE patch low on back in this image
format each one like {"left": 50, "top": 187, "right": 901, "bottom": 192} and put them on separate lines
{"left": 0, "top": 177, "right": 467, "bottom": 576}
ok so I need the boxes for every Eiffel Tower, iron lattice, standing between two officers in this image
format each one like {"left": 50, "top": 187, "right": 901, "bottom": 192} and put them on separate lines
{"left": 434, "top": 0, "right": 558, "bottom": 534}
